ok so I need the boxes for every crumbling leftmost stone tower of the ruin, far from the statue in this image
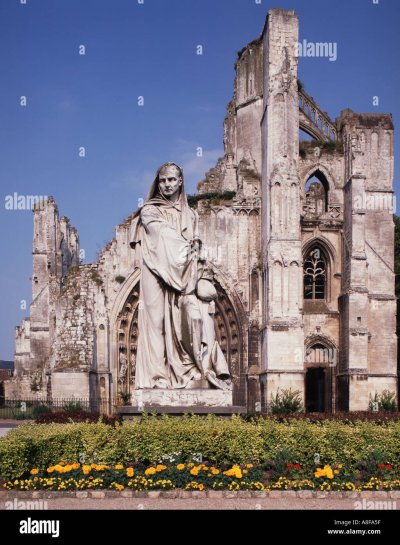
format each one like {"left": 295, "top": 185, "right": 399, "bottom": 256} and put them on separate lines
{"left": 6, "top": 197, "right": 79, "bottom": 397}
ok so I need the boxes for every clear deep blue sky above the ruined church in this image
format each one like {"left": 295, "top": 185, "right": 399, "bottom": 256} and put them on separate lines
{"left": 0, "top": 0, "right": 400, "bottom": 359}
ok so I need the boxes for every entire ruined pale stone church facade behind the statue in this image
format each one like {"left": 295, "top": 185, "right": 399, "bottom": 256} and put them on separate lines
{"left": 6, "top": 10, "right": 397, "bottom": 412}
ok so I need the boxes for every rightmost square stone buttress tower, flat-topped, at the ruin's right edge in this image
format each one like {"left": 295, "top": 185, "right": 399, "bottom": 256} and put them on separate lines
{"left": 338, "top": 110, "right": 397, "bottom": 410}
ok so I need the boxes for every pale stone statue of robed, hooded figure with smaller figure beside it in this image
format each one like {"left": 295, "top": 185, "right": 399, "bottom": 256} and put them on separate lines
{"left": 131, "top": 163, "right": 232, "bottom": 390}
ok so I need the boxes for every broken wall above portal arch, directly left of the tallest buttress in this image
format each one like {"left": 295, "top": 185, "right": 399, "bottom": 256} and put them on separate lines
{"left": 198, "top": 40, "right": 263, "bottom": 332}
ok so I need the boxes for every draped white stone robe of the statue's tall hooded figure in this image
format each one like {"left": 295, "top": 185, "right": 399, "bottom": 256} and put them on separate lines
{"left": 136, "top": 199, "right": 202, "bottom": 388}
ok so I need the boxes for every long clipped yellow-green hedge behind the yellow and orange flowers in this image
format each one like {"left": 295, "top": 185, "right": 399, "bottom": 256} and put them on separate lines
{"left": 0, "top": 416, "right": 400, "bottom": 479}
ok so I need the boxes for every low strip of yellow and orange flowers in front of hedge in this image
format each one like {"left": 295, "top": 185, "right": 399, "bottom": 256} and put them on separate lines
{"left": 3, "top": 462, "right": 400, "bottom": 492}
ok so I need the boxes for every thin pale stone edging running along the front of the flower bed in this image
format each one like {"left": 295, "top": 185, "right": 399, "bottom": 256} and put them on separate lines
{"left": 0, "top": 490, "right": 400, "bottom": 500}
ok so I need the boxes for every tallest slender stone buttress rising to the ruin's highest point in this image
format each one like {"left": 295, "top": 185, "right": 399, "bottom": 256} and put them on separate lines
{"left": 261, "top": 10, "right": 304, "bottom": 404}
